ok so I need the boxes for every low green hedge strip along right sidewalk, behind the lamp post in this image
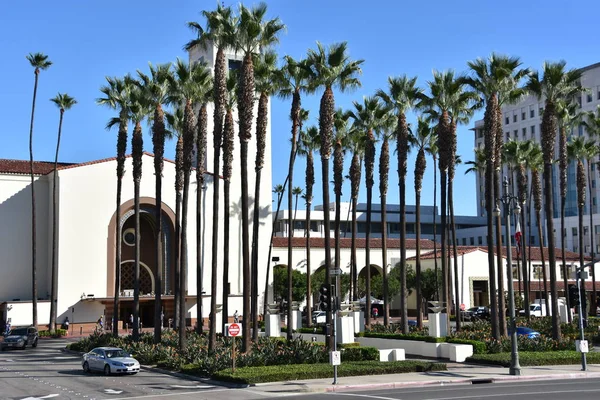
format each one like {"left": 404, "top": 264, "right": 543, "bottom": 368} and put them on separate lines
{"left": 466, "top": 350, "right": 600, "bottom": 367}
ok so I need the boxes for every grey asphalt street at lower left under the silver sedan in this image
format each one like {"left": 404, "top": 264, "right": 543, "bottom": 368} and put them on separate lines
{"left": 0, "top": 339, "right": 276, "bottom": 400}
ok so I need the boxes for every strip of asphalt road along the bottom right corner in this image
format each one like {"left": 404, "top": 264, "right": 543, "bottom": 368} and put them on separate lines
{"left": 287, "top": 379, "right": 600, "bottom": 400}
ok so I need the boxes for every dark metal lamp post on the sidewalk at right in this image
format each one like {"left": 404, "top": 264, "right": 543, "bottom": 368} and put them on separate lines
{"left": 494, "top": 177, "right": 521, "bottom": 375}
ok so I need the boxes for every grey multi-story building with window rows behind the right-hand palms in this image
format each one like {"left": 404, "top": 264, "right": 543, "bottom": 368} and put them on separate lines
{"left": 472, "top": 63, "right": 600, "bottom": 254}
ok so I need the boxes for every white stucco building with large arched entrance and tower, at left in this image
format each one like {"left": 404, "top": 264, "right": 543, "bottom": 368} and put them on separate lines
{"left": 0, "top": 44, "right": 272, "bottom": 332}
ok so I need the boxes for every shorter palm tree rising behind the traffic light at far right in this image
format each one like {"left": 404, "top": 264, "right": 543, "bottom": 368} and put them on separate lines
{"left": 567, "top": 137, "right": 598, "bottom": 318}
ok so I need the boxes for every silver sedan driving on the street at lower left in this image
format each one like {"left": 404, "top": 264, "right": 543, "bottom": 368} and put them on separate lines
{"left": 81, "top": 347, "right": 140, "bottom": 375}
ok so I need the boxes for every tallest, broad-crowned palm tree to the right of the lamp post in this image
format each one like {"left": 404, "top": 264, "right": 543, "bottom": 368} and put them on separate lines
{"left": 526, "top": 61, "right": 583, "bottom": 340}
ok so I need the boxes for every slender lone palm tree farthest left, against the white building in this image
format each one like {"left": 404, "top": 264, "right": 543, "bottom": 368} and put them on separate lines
{"left": 26, "top": 53, "right": 52, "bottom": 326}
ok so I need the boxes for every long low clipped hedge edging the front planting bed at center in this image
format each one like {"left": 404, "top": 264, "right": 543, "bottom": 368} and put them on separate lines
{"left": 211, "top": 361, "right": 446, "bottom": 384}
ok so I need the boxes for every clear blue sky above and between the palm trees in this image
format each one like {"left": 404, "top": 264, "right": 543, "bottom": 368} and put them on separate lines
{"left": 0, "top": 0, "right": 600, "bottom": 215}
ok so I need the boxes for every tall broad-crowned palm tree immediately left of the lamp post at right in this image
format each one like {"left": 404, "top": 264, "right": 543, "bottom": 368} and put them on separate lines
{"left": 465, "top": 53, "right": 529, "bottom": 339}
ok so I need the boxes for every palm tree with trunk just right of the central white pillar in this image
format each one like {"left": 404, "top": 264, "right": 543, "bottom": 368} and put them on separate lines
{"left": 349, "top": 96, "right": 388, "bottom": 328}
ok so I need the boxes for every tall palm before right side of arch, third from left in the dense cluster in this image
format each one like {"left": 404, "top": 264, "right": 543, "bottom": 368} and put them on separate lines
{"left": 137, "top": 63, "right": 171, "bottom": 343}
